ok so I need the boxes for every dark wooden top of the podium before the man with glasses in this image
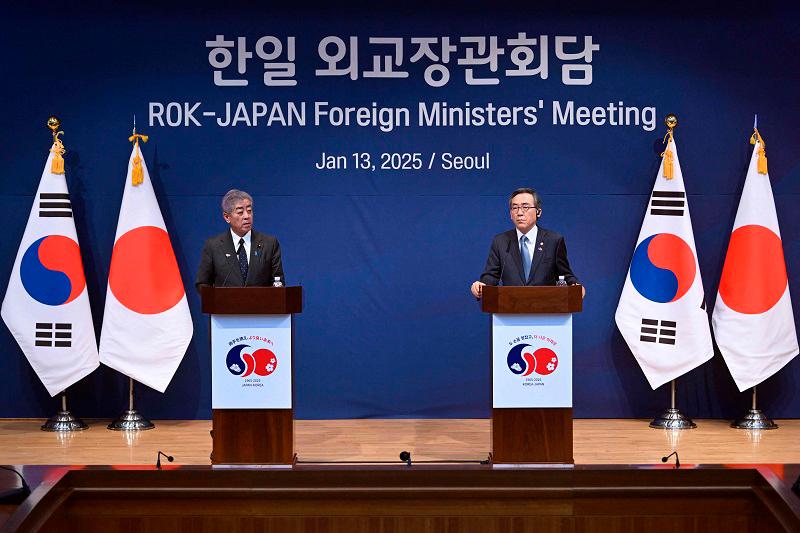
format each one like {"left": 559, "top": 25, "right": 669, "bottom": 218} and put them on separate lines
{"left": 481, "top": 285, "right": 583, "bottom": 314}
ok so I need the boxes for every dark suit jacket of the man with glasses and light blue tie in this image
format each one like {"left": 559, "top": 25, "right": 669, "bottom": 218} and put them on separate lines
{"left": 480, "top": 227, "right": 579, "bottom": 285}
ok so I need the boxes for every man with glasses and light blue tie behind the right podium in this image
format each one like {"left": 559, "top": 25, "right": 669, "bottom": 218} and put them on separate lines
{"left": 470, "top": 188, "right": 586, "bottom": 298}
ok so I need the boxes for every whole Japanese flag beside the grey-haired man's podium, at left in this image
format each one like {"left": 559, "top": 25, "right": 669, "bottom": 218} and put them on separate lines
{"left": 100, "top": 142, "right": 193, "bottom": 392}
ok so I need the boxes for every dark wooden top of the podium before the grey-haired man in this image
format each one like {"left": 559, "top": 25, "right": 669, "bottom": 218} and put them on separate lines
{"left": 200, "top": 285, "right": 303, "bottom": 315}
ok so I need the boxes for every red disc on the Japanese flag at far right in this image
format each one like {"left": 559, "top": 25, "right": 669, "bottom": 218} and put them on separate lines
{"left": 719, "top": 225, "right": 787, "bottom": 315}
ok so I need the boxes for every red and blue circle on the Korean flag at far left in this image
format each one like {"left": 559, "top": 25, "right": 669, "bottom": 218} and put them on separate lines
{"left": 19, "top": 235, "right": 86, "bottom": 305}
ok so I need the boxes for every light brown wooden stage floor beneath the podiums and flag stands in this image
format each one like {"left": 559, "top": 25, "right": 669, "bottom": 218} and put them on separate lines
{"left": 0, "top": 419, "right": 800, "bottom": 465}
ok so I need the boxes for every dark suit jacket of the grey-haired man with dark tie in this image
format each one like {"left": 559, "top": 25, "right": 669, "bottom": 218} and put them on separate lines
{"left": 195, "top": 230, "right": 286, "bottom": 290}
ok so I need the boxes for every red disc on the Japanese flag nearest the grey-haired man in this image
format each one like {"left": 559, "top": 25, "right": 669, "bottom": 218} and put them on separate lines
{"left": 108, "top": 226, "right": 184, "bottom": 315}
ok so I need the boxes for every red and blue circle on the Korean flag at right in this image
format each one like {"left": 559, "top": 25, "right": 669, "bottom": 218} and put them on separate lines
{"left": 631, "top": 233, "right": 697, "bottom": 303}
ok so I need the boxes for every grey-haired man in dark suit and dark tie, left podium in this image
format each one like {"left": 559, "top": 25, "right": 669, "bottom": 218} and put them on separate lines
{"left": 195, "top": 189, "right": 285, "bottom": 290}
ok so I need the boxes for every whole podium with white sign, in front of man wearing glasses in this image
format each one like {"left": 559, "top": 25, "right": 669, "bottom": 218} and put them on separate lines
{"left": 481, "top": 285, "right": 583, "bottom": 463}
